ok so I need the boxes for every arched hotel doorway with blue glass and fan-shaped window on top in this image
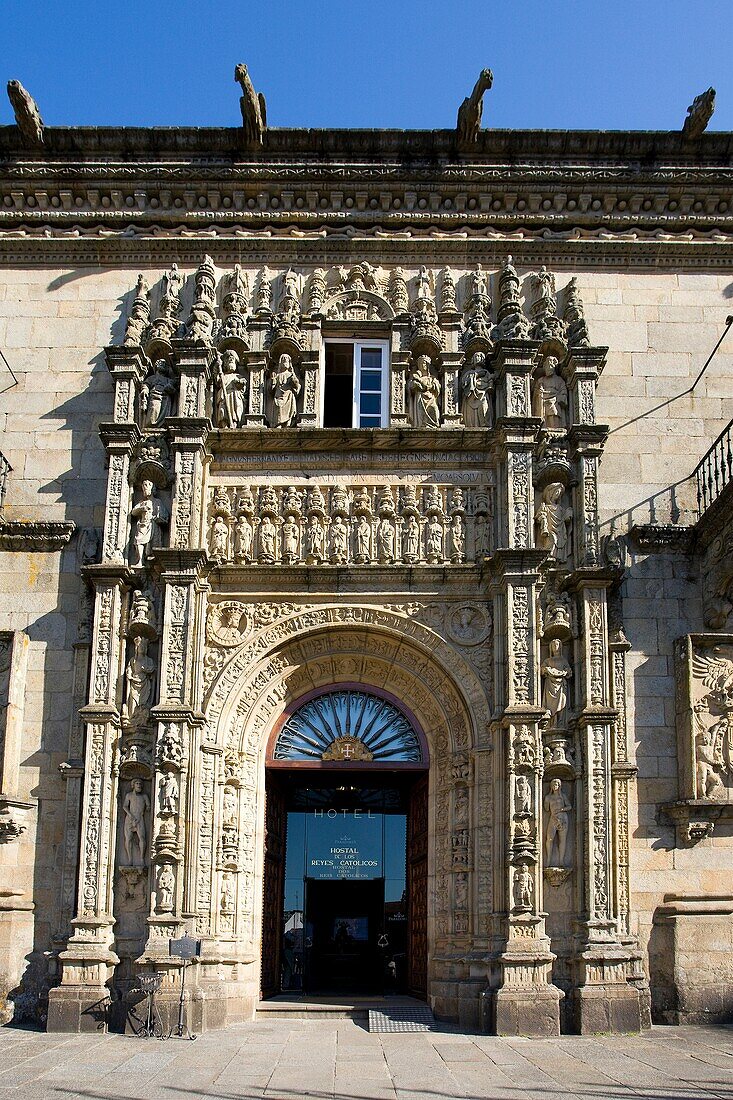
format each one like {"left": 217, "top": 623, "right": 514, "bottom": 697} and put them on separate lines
{"left": 261, "top": 683, "right": 429, "bottom": 997}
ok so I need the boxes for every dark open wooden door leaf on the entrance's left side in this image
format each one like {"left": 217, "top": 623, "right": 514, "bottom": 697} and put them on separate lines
{"left": 260, "top": 785, "right": 287, "bottom": 998}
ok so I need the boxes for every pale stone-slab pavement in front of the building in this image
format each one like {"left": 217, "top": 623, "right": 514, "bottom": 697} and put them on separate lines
{"left": 0, "top": 1020, "right": 733, "bottom": 1100}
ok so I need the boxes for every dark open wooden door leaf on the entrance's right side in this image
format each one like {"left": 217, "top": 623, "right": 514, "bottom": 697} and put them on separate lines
{"left": 407, "top": 773, "right": 428, "bottom": 999}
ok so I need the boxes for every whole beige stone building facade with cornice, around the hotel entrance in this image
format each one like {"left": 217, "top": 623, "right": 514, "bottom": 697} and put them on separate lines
{"left": 0, "top": 116, "right": 733, "bottom": 1035}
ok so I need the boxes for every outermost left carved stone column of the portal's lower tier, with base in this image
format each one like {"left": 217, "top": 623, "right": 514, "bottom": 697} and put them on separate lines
{"left": 48, "top": 563, "right": 131, "bottom": 1032}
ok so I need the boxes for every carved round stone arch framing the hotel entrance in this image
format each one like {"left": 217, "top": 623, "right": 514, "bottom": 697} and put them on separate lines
{"left": 197, "top": 606, "right": 490, "bottom": 1000}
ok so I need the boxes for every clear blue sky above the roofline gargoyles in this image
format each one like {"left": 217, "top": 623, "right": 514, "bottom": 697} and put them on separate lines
{"left": 0, "top": 0, "right": 733, "bottom": 130}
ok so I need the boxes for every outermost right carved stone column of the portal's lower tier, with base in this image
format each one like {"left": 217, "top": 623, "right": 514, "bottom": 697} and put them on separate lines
{"left": 572, "top": 570, "right": 641, "bottom": 1034}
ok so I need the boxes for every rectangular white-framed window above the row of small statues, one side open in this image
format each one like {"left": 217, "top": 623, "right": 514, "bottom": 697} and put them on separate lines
{"left": 322, "top": 340, "right": 390, "bottom": 428}
